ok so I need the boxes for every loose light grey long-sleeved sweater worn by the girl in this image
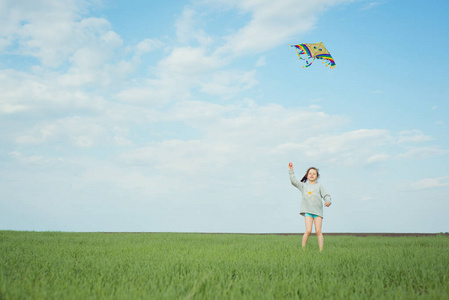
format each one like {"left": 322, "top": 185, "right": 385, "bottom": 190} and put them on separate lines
{"left": 289, "top": 170, "right": 332, "bottom": 217}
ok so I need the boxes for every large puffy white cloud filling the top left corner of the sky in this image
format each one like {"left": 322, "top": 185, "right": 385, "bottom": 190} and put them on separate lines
{"left": 0, "top": 0, "right": 143, "bottom": 87}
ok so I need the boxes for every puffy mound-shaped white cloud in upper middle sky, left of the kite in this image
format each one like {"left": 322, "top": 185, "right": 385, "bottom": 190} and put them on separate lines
{"left": 117, "top": 43, "right": 250, "bottom": 104}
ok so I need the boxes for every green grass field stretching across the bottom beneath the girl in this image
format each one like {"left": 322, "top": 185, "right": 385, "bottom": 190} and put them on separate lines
{"left": 0, "top": 231, "right": 449, "bottom": 299}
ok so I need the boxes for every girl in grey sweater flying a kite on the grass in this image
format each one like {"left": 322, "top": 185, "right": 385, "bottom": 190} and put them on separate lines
{"left": 288, "top": 163, "right": 332, "bottom": 251}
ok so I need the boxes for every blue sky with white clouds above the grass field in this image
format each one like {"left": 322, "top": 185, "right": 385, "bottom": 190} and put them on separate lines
{"left": 0, "top": 0, "right": 449, "bottom": 233}
